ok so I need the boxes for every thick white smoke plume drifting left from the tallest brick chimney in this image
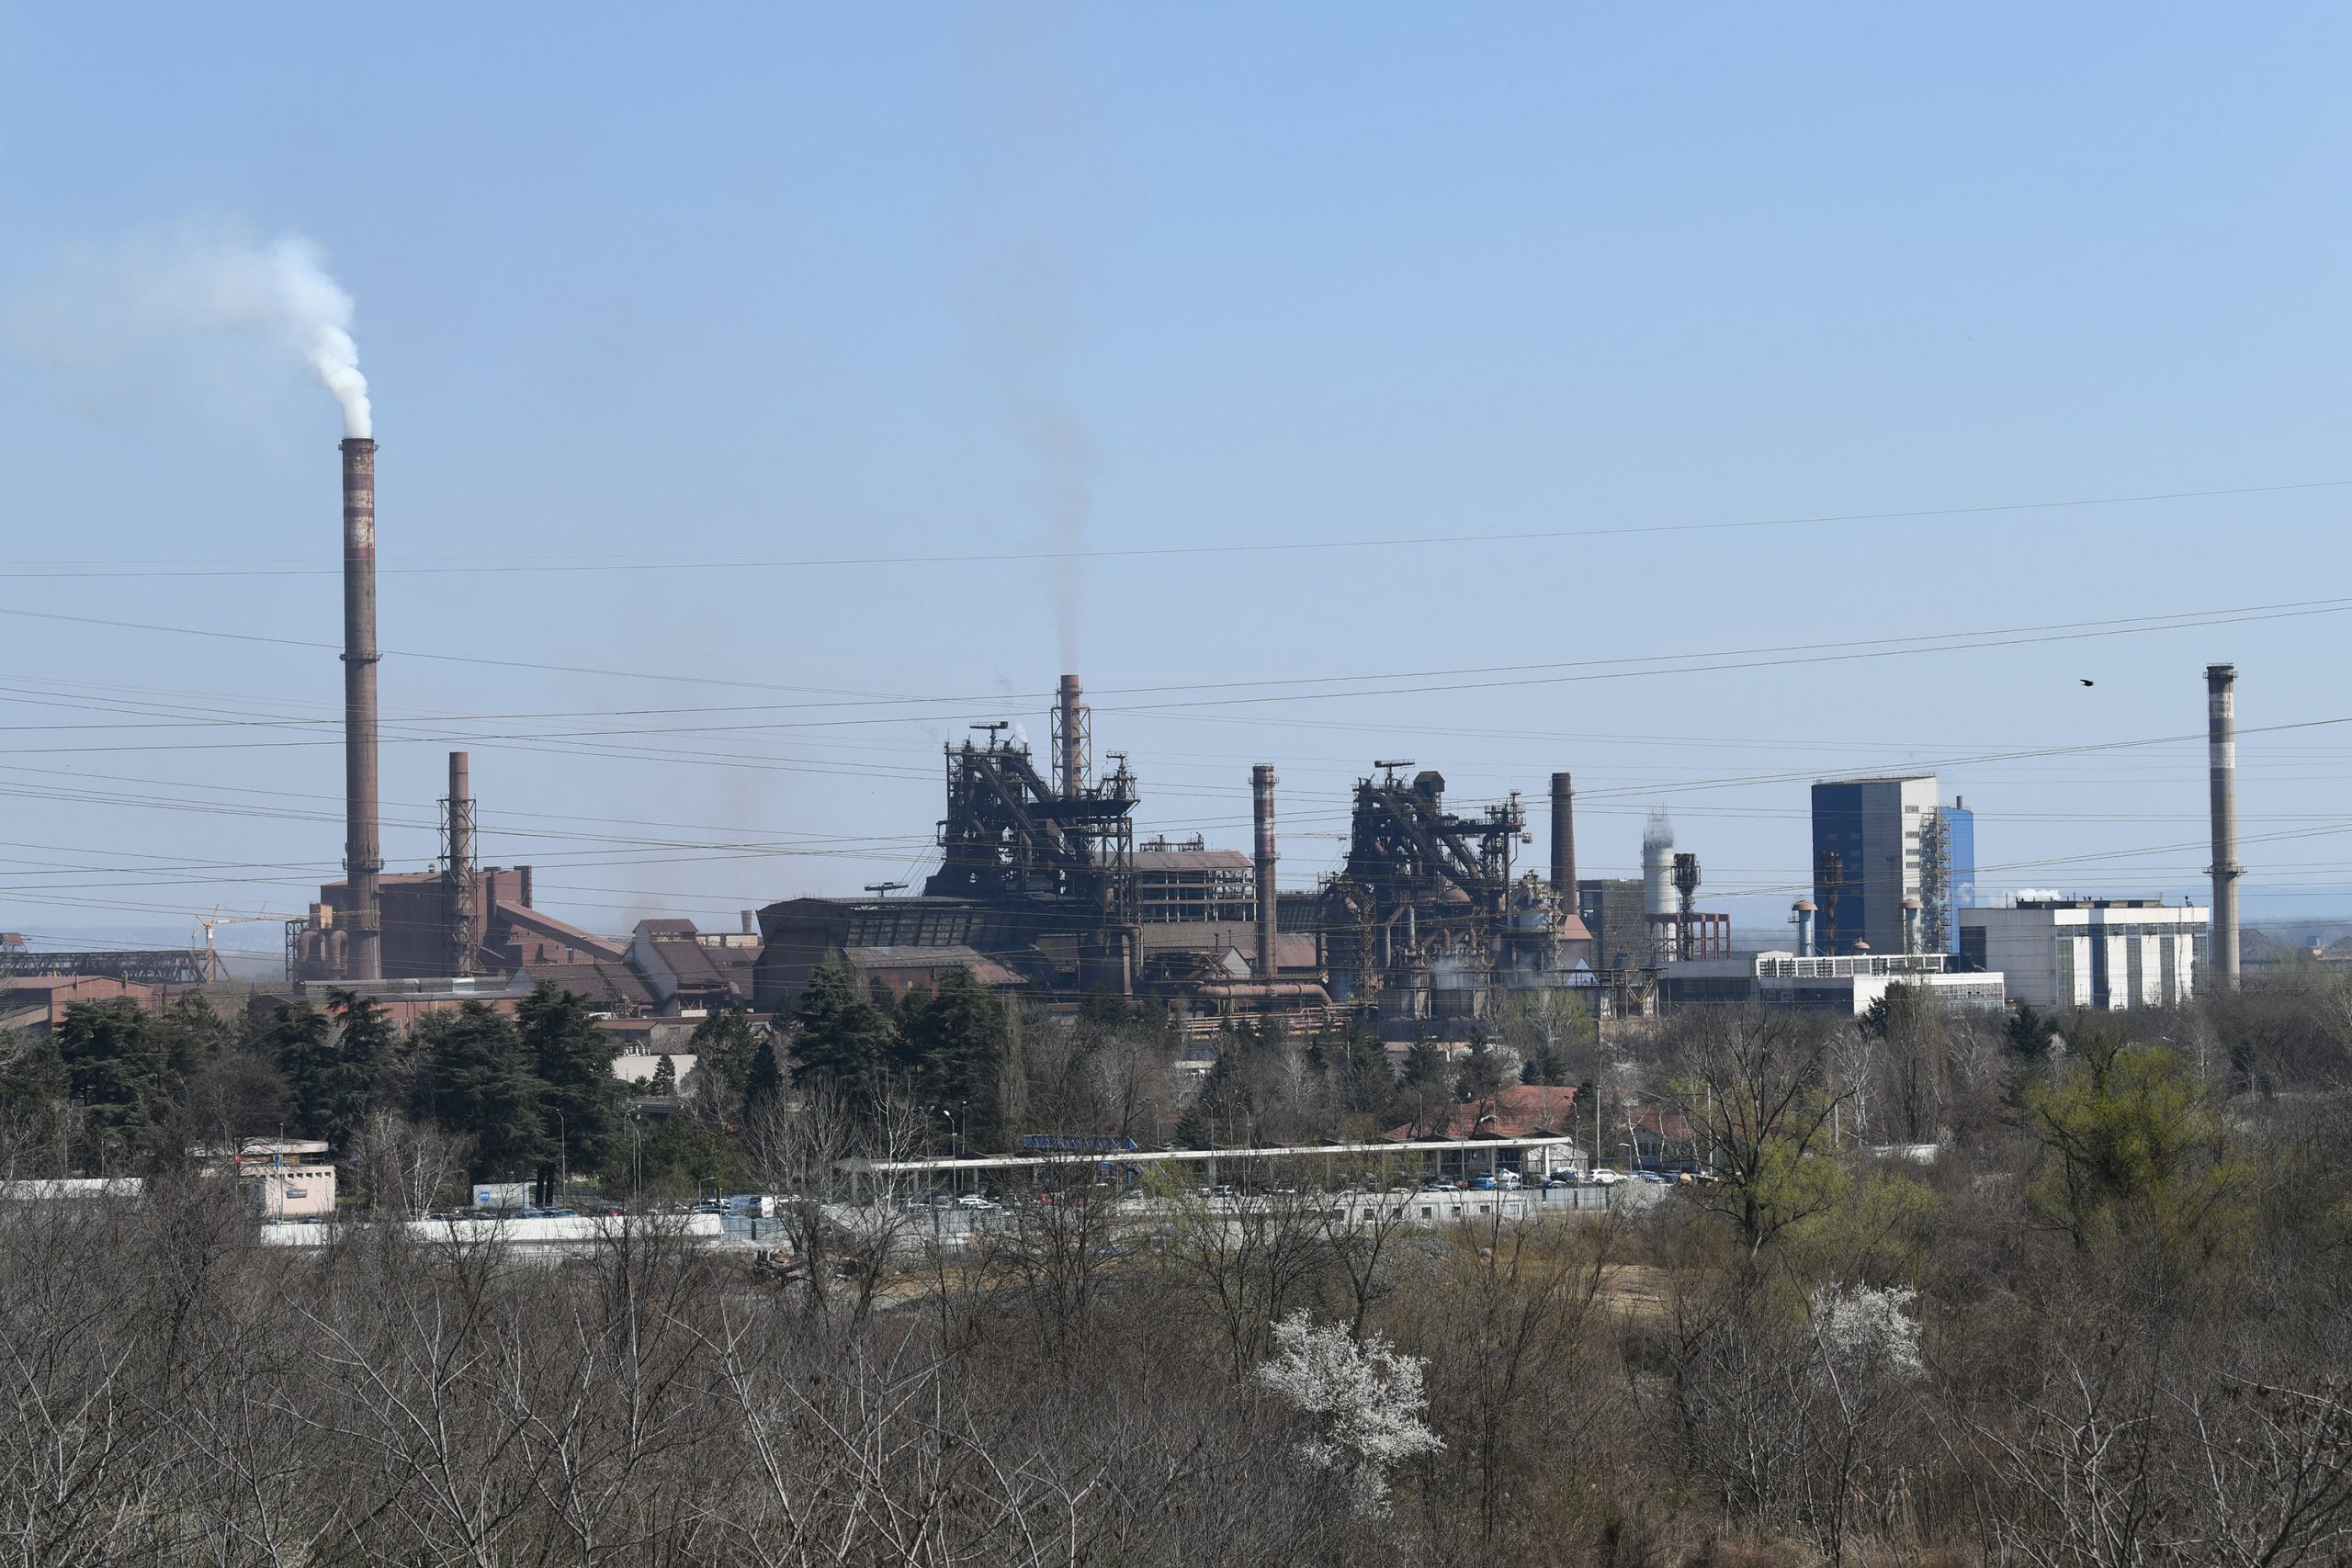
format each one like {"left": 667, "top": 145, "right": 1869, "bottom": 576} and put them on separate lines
{"left": 12, "top": 223, "right": 374, "bottom": 434}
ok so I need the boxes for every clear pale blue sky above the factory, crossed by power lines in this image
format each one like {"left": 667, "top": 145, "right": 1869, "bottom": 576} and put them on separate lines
{"left": 0, "top": 3, "right": 2352, "bottom": 941}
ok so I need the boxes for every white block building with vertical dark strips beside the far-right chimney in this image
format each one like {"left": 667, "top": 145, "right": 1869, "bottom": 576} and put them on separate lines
{"left": 1959, "top": 898, "right": 2211, "bottom": 1010}
